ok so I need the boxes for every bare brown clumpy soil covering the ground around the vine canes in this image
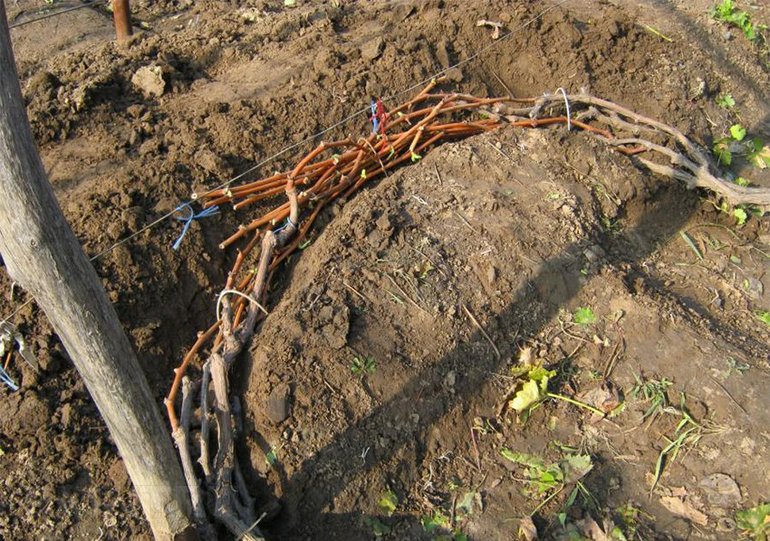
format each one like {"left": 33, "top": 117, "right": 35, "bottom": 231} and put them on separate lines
{"left": 0, "top": 0, "right": 770, "bottom": 540}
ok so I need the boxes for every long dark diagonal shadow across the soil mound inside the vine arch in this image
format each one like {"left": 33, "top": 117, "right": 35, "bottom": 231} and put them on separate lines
{"left": 254, "top": 180, "right": 697, "bottom": 540}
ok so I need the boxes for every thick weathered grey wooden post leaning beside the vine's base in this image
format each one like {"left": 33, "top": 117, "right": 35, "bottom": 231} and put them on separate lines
{"left": 0, "top": 0, "right": 197, "bottom": 541}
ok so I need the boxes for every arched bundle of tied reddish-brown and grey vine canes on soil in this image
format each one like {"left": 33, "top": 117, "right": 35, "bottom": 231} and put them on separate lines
{"left": 166, "top": 80, "right": 770, "bottom": 540}
